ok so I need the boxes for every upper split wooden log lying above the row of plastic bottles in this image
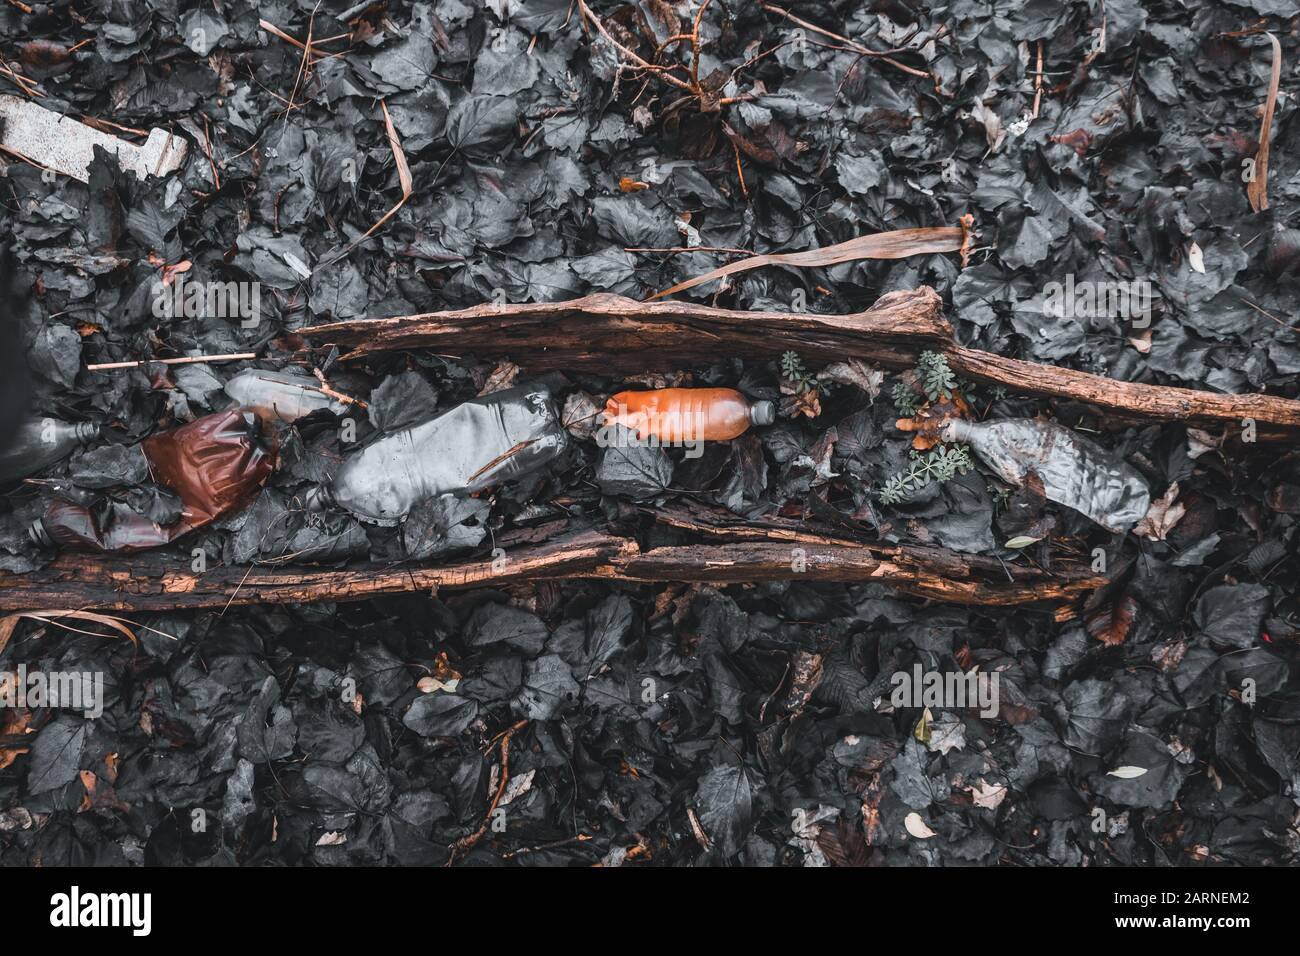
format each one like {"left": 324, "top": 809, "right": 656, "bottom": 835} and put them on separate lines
{"left": 302, "top": 286, "right": 1300, "bottom": 440}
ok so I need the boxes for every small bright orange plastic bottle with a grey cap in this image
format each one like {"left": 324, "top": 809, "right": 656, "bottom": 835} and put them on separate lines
{"left": 605, "top": 389, "right": 776, "bottom": 445}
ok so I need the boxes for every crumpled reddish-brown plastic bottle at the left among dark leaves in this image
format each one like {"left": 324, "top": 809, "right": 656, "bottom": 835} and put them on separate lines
{"left": 31, "top": 408, "right": 274, "bottom": 551}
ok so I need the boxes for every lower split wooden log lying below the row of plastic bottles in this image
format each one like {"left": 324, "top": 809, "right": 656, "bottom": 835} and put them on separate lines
{"left": 0, "top": 531, "right": 1106, "bottom": 611}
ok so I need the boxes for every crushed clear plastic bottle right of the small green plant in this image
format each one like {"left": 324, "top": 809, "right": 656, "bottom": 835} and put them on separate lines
{"left": 943, "top": 419, "right": 1151, "bottom": 531}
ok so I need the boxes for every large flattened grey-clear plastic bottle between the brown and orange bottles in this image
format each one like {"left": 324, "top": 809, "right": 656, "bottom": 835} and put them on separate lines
{"left": 308, "top": 386, "right": 568, "bottom": 524}
